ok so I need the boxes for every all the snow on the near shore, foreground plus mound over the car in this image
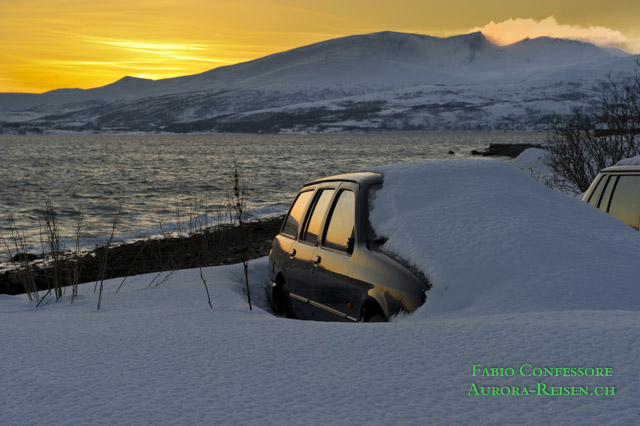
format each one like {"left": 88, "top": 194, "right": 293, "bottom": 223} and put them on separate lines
{"left": 0, "top": 161, "right": 640, "bottom": 425}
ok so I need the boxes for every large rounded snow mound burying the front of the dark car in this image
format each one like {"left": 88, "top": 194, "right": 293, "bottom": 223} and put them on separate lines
{"left": 371, "top": 161, "right": 640, "bottom": 317}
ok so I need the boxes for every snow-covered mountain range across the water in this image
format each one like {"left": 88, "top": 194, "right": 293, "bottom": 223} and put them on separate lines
{"left": 0, "top": 32, "right": 640, "bottom": 132}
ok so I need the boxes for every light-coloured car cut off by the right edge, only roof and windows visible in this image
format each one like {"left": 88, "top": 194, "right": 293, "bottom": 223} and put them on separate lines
{"left": 582, "top": 165, "right": 640, "bottom": 230}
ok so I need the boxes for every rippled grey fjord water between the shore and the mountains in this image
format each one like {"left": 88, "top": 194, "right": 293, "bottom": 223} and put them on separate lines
{"left": 0, "top": 133, "right": 544, "bottom": 248}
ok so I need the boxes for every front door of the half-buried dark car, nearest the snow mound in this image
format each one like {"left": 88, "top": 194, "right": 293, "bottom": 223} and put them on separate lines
{"left": 312, "top": 183, "right": 356, "bottom": 321}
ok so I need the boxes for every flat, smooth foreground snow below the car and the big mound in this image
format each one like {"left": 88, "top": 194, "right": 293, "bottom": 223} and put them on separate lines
{"left": 0, "top": 258, "right": 640, "bottom": 426}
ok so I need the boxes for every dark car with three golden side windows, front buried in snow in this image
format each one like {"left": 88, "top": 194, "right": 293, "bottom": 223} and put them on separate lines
{"left": 267, "top": 172, "right": 429, "bottom": 322}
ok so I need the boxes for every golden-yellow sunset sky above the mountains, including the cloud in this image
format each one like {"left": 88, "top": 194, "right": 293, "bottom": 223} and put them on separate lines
{"left": 0, "top": 0, "right": 640, "bottom": 92}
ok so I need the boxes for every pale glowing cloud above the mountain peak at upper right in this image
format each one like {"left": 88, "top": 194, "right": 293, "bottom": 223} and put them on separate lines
{"left": 469, "top": 16, "right": 630, "bottom": 51}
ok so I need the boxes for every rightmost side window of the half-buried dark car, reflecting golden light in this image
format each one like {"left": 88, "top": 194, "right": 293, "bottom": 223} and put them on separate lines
{"left": 322, "top": 190, "right": 356, "bottom": 253}
